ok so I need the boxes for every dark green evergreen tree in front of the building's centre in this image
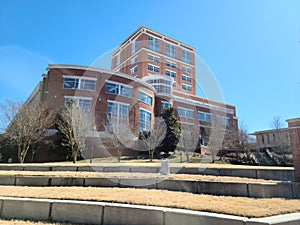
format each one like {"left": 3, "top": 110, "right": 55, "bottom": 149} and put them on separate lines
{"left": 158, "top": 107, "right": 180, "bottom": 156}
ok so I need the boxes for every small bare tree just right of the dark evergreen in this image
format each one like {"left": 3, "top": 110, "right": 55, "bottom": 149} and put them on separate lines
{"left": 177, "top": 123, "right": 199, "bottom": 162}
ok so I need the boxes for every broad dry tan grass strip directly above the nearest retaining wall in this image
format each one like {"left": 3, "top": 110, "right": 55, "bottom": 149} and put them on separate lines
{"left": 0, "top": 186, "right": 300, "bottom": 217}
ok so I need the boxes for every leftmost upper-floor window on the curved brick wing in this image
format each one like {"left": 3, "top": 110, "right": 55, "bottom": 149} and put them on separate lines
{"left": 64, "top": 77, "right": 96, "bottom": 91}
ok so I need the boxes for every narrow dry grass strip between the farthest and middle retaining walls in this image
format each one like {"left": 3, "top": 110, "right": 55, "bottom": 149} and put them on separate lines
{"left": 0, "top": 171, "right": 278, "bottom": 183}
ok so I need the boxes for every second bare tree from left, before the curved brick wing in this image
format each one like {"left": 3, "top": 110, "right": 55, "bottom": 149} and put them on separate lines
{"left": 57, "top": 101, "right": 94, "bottom": 163}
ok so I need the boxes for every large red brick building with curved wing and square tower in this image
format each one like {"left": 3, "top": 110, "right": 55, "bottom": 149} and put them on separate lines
{"left": 30, "top": 27, "right": 238, "bottom": 160}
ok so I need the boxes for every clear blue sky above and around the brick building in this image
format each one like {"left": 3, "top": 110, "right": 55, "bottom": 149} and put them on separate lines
{"left": 0, "top": 0, "right": 300, "bottom": 132}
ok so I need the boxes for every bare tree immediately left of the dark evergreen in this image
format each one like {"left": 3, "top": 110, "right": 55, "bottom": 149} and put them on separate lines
{"left": 139, "top": 118, "right": 167, "bottom": 162}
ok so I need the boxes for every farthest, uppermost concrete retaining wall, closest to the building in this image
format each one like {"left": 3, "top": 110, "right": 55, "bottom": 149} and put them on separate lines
{"left": 0, "top": 164, "right": 295, "bottom": 181}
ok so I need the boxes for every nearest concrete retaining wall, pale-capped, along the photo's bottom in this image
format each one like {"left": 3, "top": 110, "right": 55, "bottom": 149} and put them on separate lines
{"left": 0, "top": 197, "right": 300, "bottom": 225}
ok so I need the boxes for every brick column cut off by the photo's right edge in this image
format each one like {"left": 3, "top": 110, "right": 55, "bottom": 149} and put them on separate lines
{"left": 287, "top": 118, "right": 300, "bottom": 182}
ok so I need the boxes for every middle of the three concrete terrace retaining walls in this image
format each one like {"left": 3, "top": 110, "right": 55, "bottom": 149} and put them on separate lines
{"left": 0, "top": 176, "right": 300, "bottom": 199}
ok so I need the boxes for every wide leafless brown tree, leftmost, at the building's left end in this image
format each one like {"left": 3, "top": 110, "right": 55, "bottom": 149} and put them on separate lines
{"left": 0, "top": 101, "right": 55, "bottom": 163}
